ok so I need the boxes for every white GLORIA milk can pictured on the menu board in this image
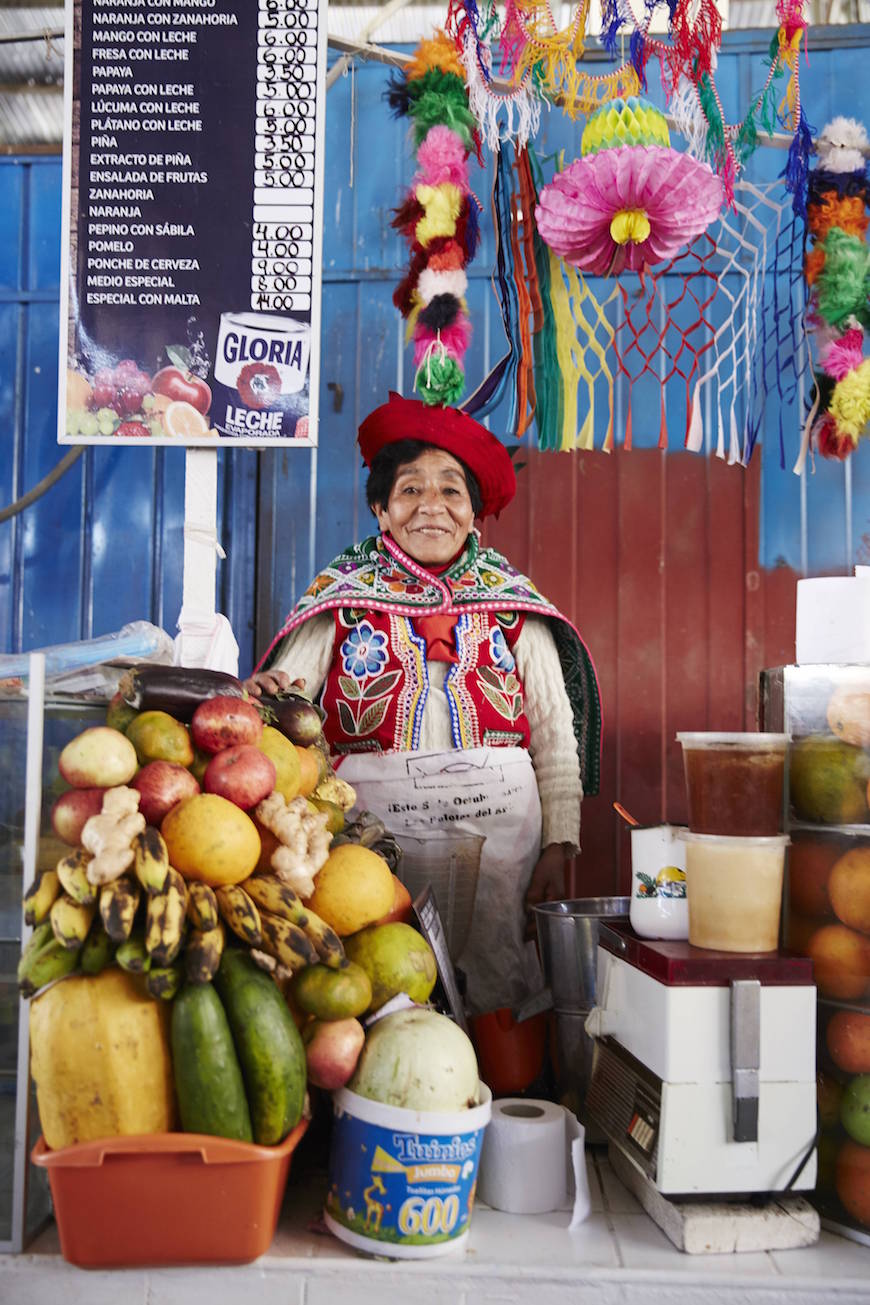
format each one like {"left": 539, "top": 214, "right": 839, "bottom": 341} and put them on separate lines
{"left": 213, "top": 313, "right": 310, "bottom": 438}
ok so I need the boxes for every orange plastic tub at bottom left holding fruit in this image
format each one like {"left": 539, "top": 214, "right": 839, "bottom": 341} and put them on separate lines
{"left": 31, "top": 1120, "right": 308, "bottom": 1268}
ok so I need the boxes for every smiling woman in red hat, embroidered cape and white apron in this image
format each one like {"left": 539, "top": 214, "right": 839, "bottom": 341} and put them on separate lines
{"left": 248, "top": 394, "right": 600, "bottom": 1014}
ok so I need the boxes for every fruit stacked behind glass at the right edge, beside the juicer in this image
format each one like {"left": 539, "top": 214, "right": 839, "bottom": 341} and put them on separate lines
{"left": 785, "top": 675, "right": 870, "bottom": 1228}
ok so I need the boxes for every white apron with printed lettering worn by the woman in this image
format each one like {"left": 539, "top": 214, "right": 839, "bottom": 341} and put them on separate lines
{"left": 340, "top": 748, "right": 543, "bottom": 1015}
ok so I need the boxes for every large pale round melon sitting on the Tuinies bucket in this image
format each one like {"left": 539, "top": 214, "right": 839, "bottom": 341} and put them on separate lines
{"left": 348, "top": 1006, "right": 479, "bottom": 1112}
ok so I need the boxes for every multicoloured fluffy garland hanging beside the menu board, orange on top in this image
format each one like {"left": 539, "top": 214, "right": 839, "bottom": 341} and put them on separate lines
{"left": 387, "top": 33, "right": 479, "bottom": 405}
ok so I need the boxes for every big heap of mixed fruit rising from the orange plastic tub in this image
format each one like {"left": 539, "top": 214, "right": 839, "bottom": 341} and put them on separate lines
{"left": 18, "top": 667, "right": 461, "bottom": 1148}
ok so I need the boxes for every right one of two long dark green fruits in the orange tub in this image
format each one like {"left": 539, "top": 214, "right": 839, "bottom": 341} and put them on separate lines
{"left": 215, "top": 949, "right": 307, "bottom": 1146}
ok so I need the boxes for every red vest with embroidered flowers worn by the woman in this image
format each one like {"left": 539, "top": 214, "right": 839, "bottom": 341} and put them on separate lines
{"left": 321, "top": 607, "right": 530, "bottom": 753}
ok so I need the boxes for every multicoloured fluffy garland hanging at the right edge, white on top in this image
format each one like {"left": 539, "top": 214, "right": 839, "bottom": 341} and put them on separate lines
{"left": 796, "top": 117, "right": 870, "bottom": 470}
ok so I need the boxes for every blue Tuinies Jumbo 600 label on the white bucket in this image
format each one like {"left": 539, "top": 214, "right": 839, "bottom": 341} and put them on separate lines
{"left": 326, "top": 1112, "right": 484, "bottom": 1254}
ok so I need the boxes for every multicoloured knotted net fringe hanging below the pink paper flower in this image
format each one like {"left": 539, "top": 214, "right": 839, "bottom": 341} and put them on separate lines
{"left": 464, "top": 144, "right": 809, "bottom": 466}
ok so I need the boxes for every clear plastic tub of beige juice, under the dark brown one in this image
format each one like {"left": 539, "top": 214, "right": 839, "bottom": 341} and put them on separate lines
{"left": 681, "top": 830, "right": 789, "bottom": 951}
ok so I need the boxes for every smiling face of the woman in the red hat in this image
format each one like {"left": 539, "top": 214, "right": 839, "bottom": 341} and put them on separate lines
{"left": 376, "top": 449, "right": 475, "bottom": 566}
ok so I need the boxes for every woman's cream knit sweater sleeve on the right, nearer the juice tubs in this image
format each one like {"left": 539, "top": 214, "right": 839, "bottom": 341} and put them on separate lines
{"left": 514, "top": 616, "right": 583, "bottom": 851}
